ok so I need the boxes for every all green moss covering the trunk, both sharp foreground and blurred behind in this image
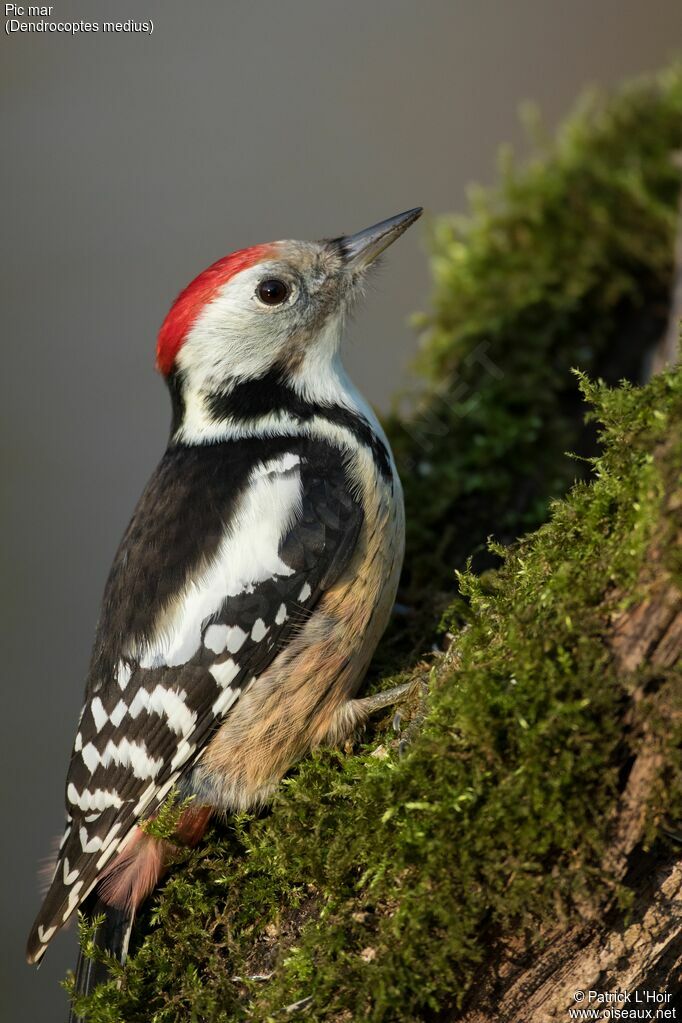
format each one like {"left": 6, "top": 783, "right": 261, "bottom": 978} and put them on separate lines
{"left": 65, "top": 73, "right": 682, "bottom": 1023}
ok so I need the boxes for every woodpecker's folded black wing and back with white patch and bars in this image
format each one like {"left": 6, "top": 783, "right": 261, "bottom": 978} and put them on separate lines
{"left": 29, "top": 438, "right": 363, "bottom": 959}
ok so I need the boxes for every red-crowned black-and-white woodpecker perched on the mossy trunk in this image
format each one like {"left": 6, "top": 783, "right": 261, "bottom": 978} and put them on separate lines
{"left": 27, "top": 203, "right": 421, "bottom": 1019}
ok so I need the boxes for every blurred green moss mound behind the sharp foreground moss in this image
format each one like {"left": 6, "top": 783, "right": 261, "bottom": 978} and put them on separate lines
{"left": 391, "top": 61, "right": 682, "bottom": 605}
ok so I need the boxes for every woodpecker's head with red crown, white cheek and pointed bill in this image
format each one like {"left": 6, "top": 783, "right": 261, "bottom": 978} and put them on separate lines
{"left": 156, "top": 209, "right": 421, "bottom": 431}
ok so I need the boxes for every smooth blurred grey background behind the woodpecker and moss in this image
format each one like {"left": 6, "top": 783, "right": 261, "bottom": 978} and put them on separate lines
{"left": 0, "top": 0, "right": 682, "bottom": 1023}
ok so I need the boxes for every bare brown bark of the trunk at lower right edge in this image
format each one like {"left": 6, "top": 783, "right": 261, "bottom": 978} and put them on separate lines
{"left": 462, "top": 468, "right": 682, "bottom": 1023}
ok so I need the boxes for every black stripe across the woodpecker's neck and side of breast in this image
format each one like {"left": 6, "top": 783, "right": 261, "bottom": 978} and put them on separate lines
{"left": 207, "top": 367, "right": 392, "bottom": 480}
